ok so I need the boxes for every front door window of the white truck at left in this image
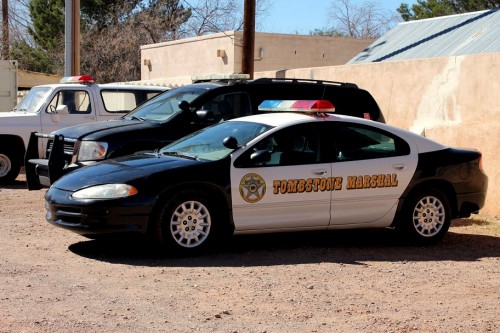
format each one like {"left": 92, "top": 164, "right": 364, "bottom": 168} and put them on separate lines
{"left": 45, "top": 90, "right": 92, "bottom": 114}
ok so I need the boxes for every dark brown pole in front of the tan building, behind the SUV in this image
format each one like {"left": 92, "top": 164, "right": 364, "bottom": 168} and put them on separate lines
{"left": 241, "top": 0, "right": 255, "bottom": 79}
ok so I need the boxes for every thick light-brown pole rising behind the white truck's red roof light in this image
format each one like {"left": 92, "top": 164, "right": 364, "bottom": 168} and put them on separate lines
{"left": 64, "top": 0, "right": 80, "bottom": 76}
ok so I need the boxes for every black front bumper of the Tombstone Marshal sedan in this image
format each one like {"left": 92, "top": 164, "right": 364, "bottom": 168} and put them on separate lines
{"left": 45, "top": 187, "right": 151, "bottom": 237}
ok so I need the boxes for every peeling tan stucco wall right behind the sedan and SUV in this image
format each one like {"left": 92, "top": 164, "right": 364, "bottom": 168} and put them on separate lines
{"left": 255, "top": 53, "right": 500, "bottom": 217}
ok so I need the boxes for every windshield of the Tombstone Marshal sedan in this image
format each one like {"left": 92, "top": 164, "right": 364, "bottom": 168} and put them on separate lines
{"left": 160, "top": 121, "right": 272, "bottom": 161}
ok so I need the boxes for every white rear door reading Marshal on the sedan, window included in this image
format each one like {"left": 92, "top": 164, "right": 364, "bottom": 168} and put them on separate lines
{"left": 329, "top": 122, "right": 418, "bottom": 227}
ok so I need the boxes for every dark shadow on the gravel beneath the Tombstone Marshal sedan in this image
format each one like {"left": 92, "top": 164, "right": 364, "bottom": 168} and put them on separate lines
{"left": 69, "top": 224, "right": 500, "bottom": 267}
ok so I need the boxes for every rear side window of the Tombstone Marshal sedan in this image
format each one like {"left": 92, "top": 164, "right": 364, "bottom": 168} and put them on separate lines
{"left": 333, "top": 124, "right": 410, "bottom": 162}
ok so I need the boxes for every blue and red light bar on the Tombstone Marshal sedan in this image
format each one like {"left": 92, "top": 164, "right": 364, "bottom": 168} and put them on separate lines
{"left": 259, "top": 100, "right": 335, "bottom": 113}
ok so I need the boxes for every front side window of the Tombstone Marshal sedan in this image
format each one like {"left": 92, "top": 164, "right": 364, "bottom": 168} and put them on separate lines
{"left": 241, "top": 124, "right": 321, "bottom": 166}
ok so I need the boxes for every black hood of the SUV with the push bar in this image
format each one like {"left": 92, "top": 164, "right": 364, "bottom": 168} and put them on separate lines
{"left": 52, "top": 119, "right": 159, "bottom": 140}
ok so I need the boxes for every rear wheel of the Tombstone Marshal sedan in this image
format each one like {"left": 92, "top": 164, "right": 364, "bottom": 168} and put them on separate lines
{"left": 399, "top": 188, "right": 451, "bottom": 245}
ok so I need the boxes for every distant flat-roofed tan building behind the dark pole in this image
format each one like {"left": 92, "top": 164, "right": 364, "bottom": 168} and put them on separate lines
{"left": 141, "top": 31, "right": 373, "bottom": 85}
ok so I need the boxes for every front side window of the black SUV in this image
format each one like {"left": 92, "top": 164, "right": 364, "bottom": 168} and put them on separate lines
{"left": 202, "top": 92, "right": 252, "bottom": 122}
